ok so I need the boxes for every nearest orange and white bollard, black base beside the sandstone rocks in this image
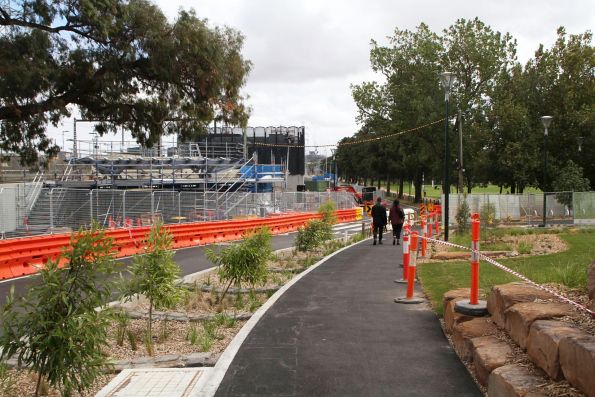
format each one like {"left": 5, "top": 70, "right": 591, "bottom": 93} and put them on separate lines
{"left": 455, "top": 213, "right": 488, "bottom": 316}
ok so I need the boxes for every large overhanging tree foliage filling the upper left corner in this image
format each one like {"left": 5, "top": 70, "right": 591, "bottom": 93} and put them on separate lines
{"left": 0, "top": 0, "right": 251, "bottom": 163}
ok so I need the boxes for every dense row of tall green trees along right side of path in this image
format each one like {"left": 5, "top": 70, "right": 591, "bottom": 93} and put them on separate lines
{"left": 337, "top": 18, "right": 595, "bottom": 200}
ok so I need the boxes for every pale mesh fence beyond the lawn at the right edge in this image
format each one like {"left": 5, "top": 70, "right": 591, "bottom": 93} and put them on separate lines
{"left": 442, "top": 192, "right": 595, "bottom": 225}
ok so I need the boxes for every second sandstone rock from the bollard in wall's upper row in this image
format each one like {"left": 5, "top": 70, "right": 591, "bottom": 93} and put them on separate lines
{"left": 504, "top": 302, "right": 571, "bottom": 349}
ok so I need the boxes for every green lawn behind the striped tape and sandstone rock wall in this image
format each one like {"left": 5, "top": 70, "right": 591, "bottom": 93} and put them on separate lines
{"left": 417, "top": 229, "right": 595, "bottom": 316}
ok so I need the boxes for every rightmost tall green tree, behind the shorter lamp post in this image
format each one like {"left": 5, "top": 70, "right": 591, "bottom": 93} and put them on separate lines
{"left": 524, "top": 27, "right": 595, "bottom": 191}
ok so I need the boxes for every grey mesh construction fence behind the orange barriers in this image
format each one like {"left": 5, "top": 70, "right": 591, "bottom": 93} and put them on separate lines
{"left": 0, "top": 184, "right": 357, "bottom": 238}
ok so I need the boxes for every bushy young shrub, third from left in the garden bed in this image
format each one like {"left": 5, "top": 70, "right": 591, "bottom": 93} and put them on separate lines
{"left": 206, "top": 227, "right": 273, "bottom": 301}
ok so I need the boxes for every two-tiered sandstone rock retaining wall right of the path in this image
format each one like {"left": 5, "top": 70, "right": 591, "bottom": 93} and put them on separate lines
{"left": 443, "top": 283, "right": 595, "bottom": 397}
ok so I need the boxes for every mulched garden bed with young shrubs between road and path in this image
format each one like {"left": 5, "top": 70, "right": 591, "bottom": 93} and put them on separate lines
{"left": 0, "top": 203, "right": 361, "bottom": 396}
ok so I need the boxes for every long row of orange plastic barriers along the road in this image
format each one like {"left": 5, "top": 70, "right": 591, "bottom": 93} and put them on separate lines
{"left": 0, "top": 208, "right": 358, "bottom": 279}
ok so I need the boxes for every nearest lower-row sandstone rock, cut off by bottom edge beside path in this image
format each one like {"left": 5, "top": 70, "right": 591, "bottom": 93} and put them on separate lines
{"left": 488, "top": 364, "right": 546, "bottom": 397}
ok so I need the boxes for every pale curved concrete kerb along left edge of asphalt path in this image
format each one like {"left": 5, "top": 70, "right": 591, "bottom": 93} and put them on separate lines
{"left": 196, "top": 235, "right": 369, "bottom": 397}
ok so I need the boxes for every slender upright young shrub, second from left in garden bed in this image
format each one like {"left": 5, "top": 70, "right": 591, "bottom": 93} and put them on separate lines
{"left": 124, "top": 222, "right": 184, "bottom": 339}
